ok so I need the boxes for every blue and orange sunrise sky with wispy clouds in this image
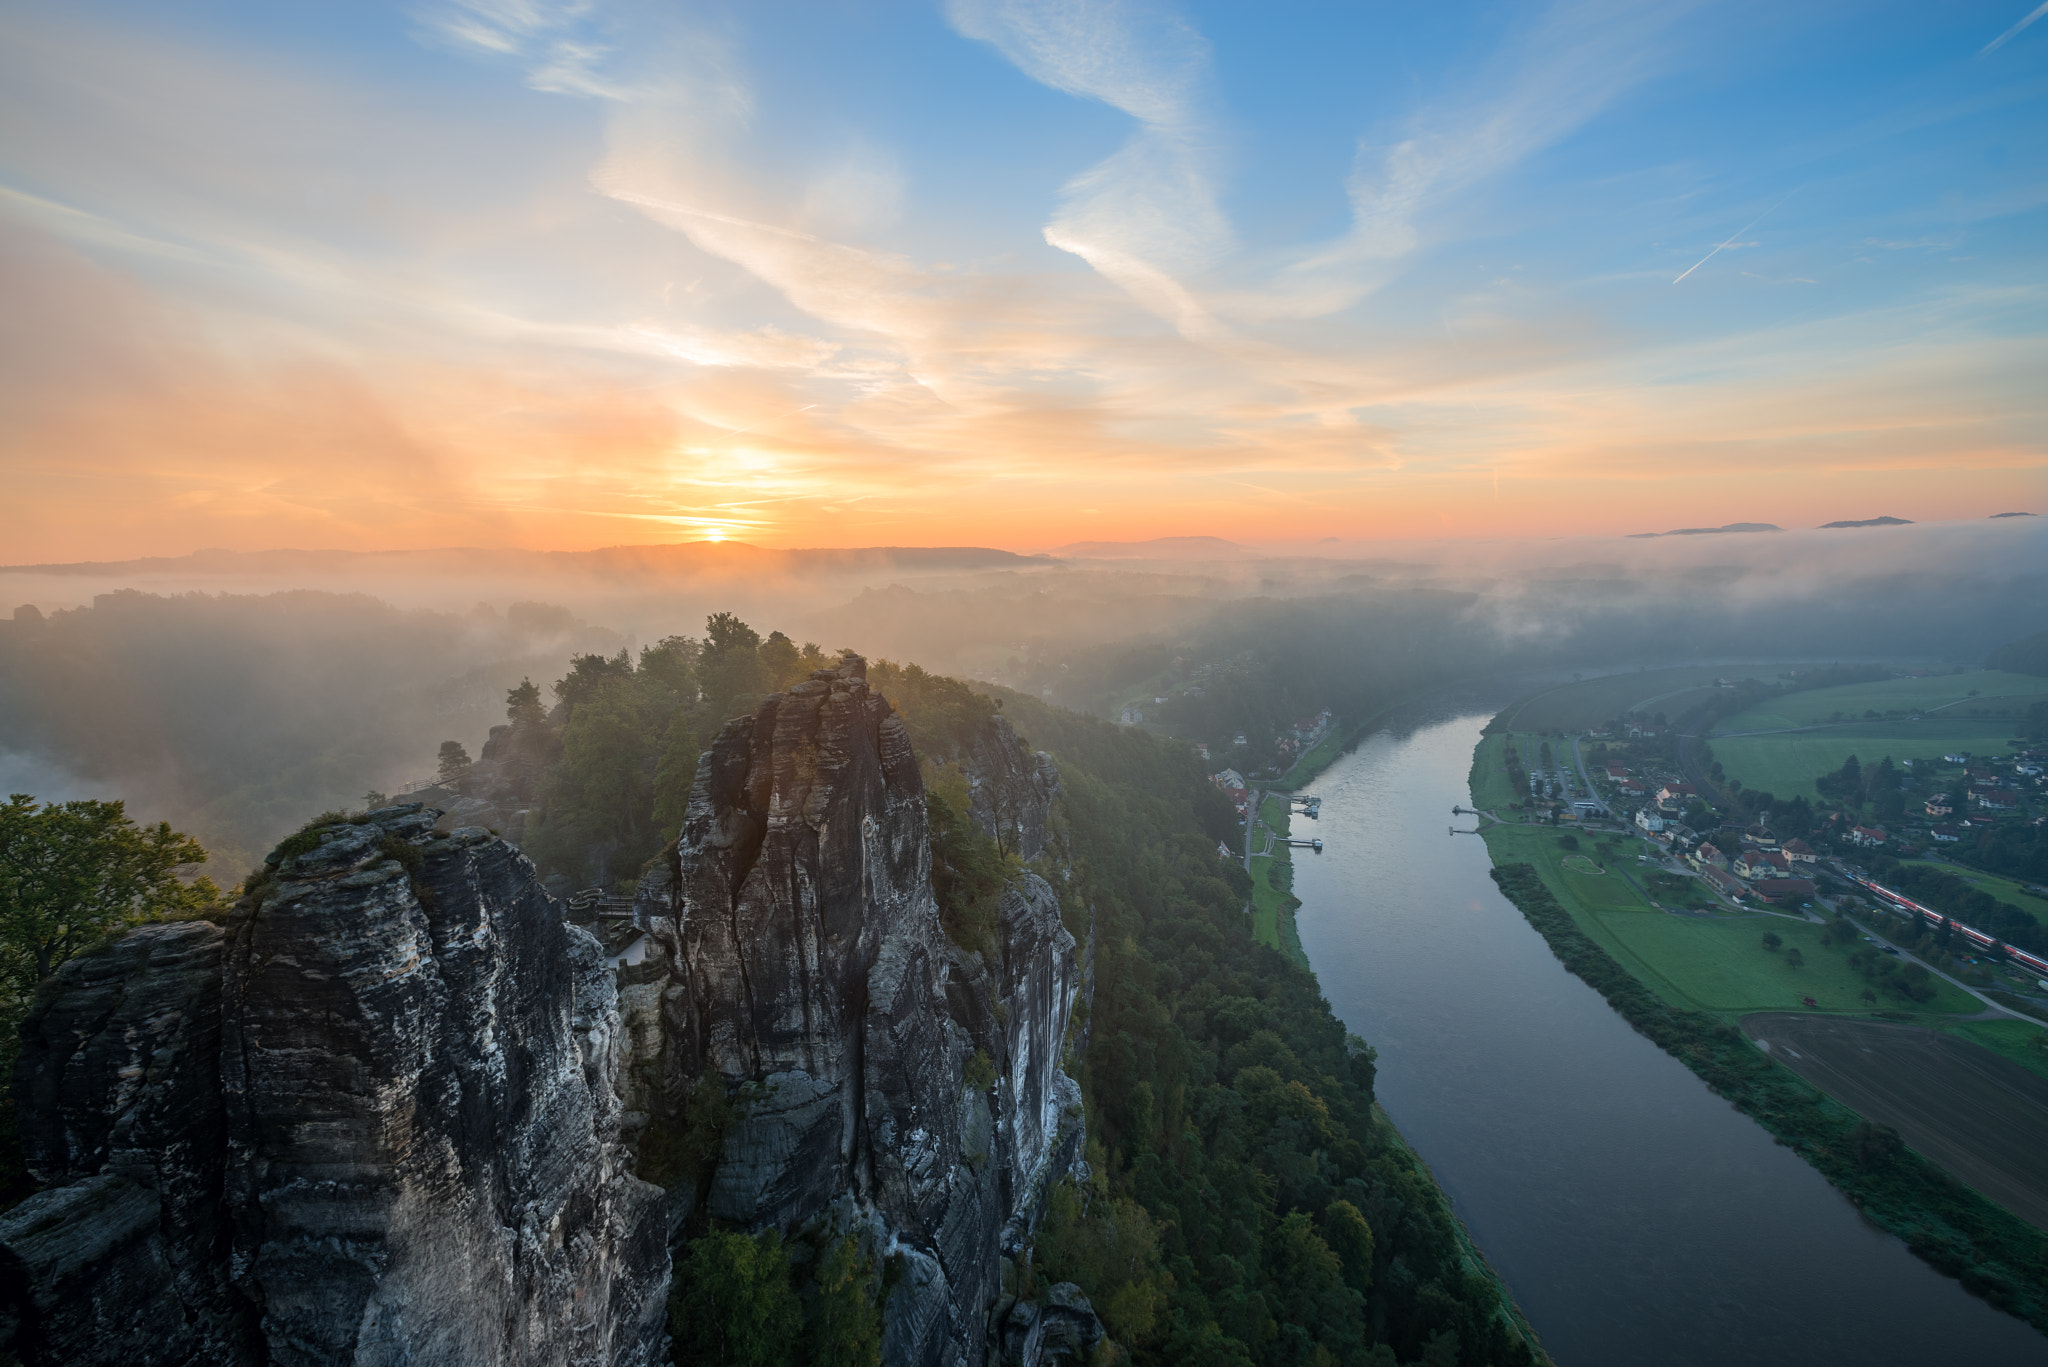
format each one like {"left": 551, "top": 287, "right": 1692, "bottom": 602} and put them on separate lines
{"left": 0, "top": 0, "right": 2048, "bottom": 564}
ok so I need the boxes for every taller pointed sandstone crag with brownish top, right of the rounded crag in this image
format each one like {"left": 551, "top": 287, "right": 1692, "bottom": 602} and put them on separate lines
{"left": 633, "top": 660, "right": 1079, "bottom": 1363}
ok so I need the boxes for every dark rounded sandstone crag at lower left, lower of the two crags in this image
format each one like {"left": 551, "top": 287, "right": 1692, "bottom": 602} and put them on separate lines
{"left": 0, "top": 805, "right": 668, "bottom": 1365}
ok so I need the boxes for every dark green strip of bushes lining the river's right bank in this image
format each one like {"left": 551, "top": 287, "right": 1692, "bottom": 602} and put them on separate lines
{"left": 1493, "top": 863, "right": 2048, "bottom": 1330}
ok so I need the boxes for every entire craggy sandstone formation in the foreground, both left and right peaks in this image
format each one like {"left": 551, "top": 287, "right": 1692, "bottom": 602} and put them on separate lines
{"left": 0, "top": 658, "right": 1100, "bottom": 1367}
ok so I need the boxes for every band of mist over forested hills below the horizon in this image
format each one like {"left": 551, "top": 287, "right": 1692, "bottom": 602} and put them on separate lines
{"left": 0, "top": 519, "right": 2048, "bottom": 879}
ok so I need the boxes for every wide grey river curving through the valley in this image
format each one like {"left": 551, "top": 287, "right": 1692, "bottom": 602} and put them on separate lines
{"left": 1294, "top": 697, "right": 2048, "bottom": 1367}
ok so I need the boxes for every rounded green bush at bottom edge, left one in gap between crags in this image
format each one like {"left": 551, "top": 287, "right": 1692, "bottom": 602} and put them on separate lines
{"left": 668, "top": 1230, "right": 803, "bottom": 1367}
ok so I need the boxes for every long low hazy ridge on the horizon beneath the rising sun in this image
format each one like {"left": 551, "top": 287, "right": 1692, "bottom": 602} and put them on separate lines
{"left": 0, "top": 541, "right": 1047, "bottom": 580}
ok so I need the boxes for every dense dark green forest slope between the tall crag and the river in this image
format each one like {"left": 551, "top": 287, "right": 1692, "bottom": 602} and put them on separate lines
{"left": 983, "top": 695, "right": 1534, "bottom": 1367}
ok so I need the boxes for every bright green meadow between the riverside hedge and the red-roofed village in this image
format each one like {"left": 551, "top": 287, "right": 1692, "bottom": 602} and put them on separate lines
{"left": 1487, "top": 811, "right": 1982, "bottom": 1023}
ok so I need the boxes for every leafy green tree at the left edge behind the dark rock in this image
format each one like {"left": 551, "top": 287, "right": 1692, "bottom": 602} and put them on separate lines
{"left": 0, "top": 793, "right": 219, "bottom": 992}
